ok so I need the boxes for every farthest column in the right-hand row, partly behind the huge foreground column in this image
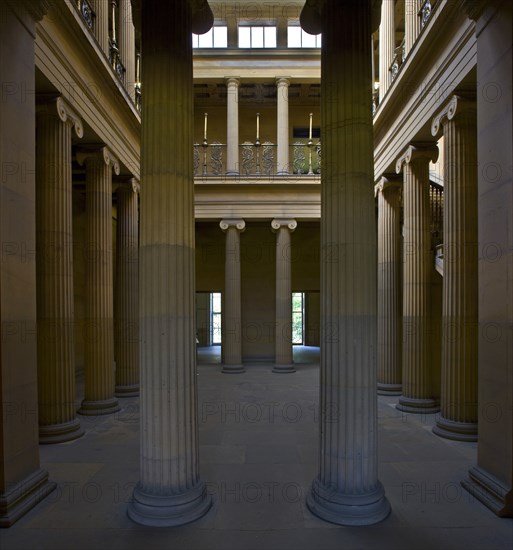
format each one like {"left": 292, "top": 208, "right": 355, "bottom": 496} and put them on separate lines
{"left": 376, "top": 177, "right": 402, "bottom": 395}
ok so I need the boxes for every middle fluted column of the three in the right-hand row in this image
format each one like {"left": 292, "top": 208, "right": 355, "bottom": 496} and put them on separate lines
{"left": 396, "top": 145, "right": 439, "bottom": 413}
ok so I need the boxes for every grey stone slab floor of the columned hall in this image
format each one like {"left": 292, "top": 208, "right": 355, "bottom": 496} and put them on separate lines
{"left": 0, "top": 348, "right": 513, "bottom": 550}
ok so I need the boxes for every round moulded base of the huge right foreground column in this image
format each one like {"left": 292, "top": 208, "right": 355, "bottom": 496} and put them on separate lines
{"left": 306, "top": 479, "right": 390, "bottom": 525}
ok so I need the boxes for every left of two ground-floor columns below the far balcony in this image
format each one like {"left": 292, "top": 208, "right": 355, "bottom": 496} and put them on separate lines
{"left": 219, "top": 219, "right": 246, "bottom": 374}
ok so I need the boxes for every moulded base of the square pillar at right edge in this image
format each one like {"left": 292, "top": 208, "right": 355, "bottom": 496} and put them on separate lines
{"left": 461, "top": 466, "right": 513, "bottom": 518}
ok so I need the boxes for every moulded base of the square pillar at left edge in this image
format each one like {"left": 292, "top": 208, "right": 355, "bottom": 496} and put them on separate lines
{"left": 0, "top": 469, "right": 57, "bottom": 527}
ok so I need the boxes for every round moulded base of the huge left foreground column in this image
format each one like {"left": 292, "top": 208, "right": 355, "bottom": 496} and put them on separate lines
{"left": 127, "top": 482, "right": 212, "bottom": 527}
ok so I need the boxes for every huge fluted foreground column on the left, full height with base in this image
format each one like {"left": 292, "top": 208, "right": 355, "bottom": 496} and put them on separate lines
{"left": 128, "top": 0, "right": 211, "bottom": 526}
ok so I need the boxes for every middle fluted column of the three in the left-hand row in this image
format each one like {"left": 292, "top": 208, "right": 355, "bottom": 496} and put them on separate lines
{"left": 77, "top": 147, "right": 119, "bottom": 416}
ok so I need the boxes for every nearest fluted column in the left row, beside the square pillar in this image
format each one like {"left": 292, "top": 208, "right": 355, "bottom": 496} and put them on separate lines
{"left": 36, "top": 97, "right": 84, "bottom": 443}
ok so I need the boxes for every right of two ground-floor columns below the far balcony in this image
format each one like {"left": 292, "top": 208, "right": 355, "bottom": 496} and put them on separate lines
{"left": 271, "top": 219, "right": 297, "bottom": 373}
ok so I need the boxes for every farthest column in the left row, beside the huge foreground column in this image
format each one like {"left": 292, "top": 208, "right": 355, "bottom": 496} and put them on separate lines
{"left": 114, "top": 179, "right": 139, "bottom": 397}
